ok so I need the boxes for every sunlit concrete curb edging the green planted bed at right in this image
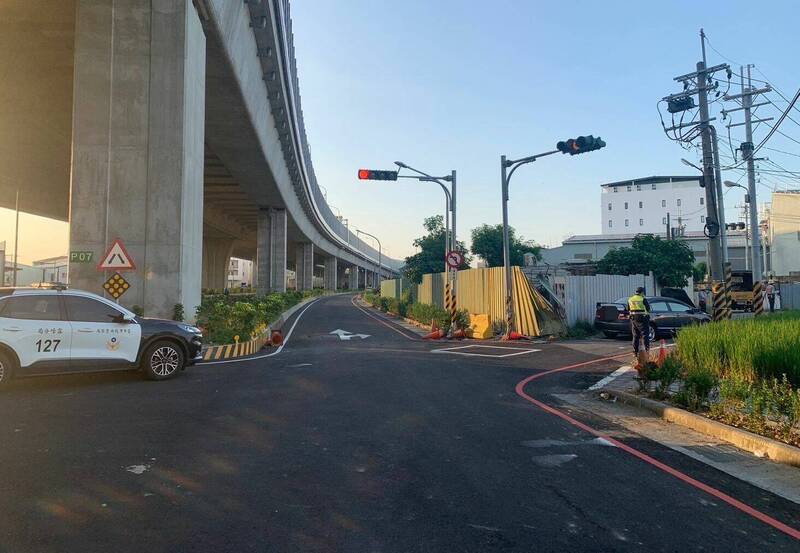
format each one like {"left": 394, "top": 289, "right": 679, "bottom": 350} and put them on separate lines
{"left": 599, "top": 389, "right": 800, "bottom": 467}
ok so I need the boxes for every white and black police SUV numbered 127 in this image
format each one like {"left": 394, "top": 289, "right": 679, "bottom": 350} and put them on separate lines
{"left": 0, "top": 286, "right": 202, "bottom": 387}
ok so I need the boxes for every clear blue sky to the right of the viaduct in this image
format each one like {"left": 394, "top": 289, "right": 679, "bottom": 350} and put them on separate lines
{"left": 291, "top": 0, "right": 800, "bottom": 257}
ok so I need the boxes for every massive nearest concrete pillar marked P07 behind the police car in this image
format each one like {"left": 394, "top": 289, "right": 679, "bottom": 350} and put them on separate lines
{"left": 69, "top": 0, "right": 206, "bottom": 317}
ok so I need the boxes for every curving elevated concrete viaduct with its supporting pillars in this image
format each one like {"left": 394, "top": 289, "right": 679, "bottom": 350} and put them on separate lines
{"left": 0, "top": 0, "right": 400, "bottom": 316}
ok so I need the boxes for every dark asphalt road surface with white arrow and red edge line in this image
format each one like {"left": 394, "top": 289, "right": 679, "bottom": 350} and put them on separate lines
{"left": 0, "top": 296, "right": 800, "bottom": 553}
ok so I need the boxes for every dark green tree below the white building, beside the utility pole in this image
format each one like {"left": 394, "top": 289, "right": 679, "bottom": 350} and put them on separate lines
{"left": 597, "top": 234, "right": 694, "bottom": 288}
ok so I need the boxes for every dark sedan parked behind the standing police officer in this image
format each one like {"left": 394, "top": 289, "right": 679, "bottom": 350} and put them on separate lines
{"left": 594, "top": 296, "right": 711, "bottom": 341}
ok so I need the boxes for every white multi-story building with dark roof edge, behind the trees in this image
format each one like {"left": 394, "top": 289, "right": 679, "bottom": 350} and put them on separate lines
{"left": 600, "top": 176, "right": 706, "bottom": 234}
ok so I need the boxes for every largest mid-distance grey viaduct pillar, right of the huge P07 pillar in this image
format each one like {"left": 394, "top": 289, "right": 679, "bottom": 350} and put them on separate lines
{"left": 256, "top": 208, "right": 286, "bottom": 295}
